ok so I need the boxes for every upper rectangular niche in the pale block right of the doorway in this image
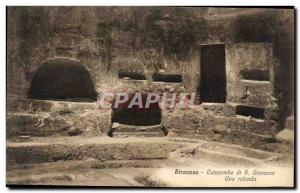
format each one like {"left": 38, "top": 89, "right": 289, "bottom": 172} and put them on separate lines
{"left": 240, "top": 69, "right": 270, "bottom": 81}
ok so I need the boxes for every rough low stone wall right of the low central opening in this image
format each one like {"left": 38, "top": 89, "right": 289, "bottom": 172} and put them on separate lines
{"left": 162, "top": 105, "right": 276, "bottom": 146}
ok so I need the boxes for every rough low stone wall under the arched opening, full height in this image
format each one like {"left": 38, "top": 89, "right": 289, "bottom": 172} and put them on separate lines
{"left": 7, "top": 100, "right": 111, "bottom": 137}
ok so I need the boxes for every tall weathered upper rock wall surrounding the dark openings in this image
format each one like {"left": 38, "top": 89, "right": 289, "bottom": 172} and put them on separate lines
{"left": 7, "top": 7, "right": 294, "bottom": 131}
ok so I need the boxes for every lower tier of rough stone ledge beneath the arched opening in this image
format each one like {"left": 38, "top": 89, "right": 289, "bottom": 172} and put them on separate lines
{"left": 6, "top": 108, "right": 111, "bottom": 140}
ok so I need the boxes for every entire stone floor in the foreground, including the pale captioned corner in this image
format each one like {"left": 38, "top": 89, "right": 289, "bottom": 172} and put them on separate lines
{"left": 6, "top": 136, "right": 293, "bottom": 187}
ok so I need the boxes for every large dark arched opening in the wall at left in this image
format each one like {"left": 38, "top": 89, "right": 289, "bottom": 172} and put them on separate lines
{"left": 28, "top": 58, "right": 97, "bottom": 102}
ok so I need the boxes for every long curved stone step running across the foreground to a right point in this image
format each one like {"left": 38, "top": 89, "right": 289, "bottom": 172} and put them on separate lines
{"left": 6, "top": 137, "right": 282, "bottom": 169}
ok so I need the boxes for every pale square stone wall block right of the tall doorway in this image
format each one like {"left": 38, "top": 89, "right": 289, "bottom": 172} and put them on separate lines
{"left": 226, "top": 43, "right": 275, "bottom": 107}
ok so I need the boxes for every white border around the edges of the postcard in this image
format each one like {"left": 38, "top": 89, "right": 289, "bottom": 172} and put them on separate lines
{"left": 0, "top": 0, "right": 300, "bottom": 193}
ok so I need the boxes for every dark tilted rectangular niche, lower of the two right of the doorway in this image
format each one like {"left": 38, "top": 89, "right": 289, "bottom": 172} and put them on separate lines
{"left": 235, "top": 105, "right": 265, "bottom": 119}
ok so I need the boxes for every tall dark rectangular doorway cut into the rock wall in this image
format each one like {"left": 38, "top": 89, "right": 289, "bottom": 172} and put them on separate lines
{"left": 200, "top": 44, "right": 226, "bottom": 103}
